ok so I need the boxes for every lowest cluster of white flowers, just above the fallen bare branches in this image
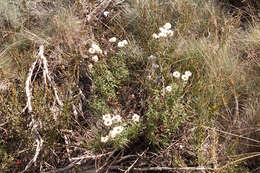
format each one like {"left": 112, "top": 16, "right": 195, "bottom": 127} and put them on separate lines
{"left": 100, "top": 114, "right": 140, "bottom": 143}
